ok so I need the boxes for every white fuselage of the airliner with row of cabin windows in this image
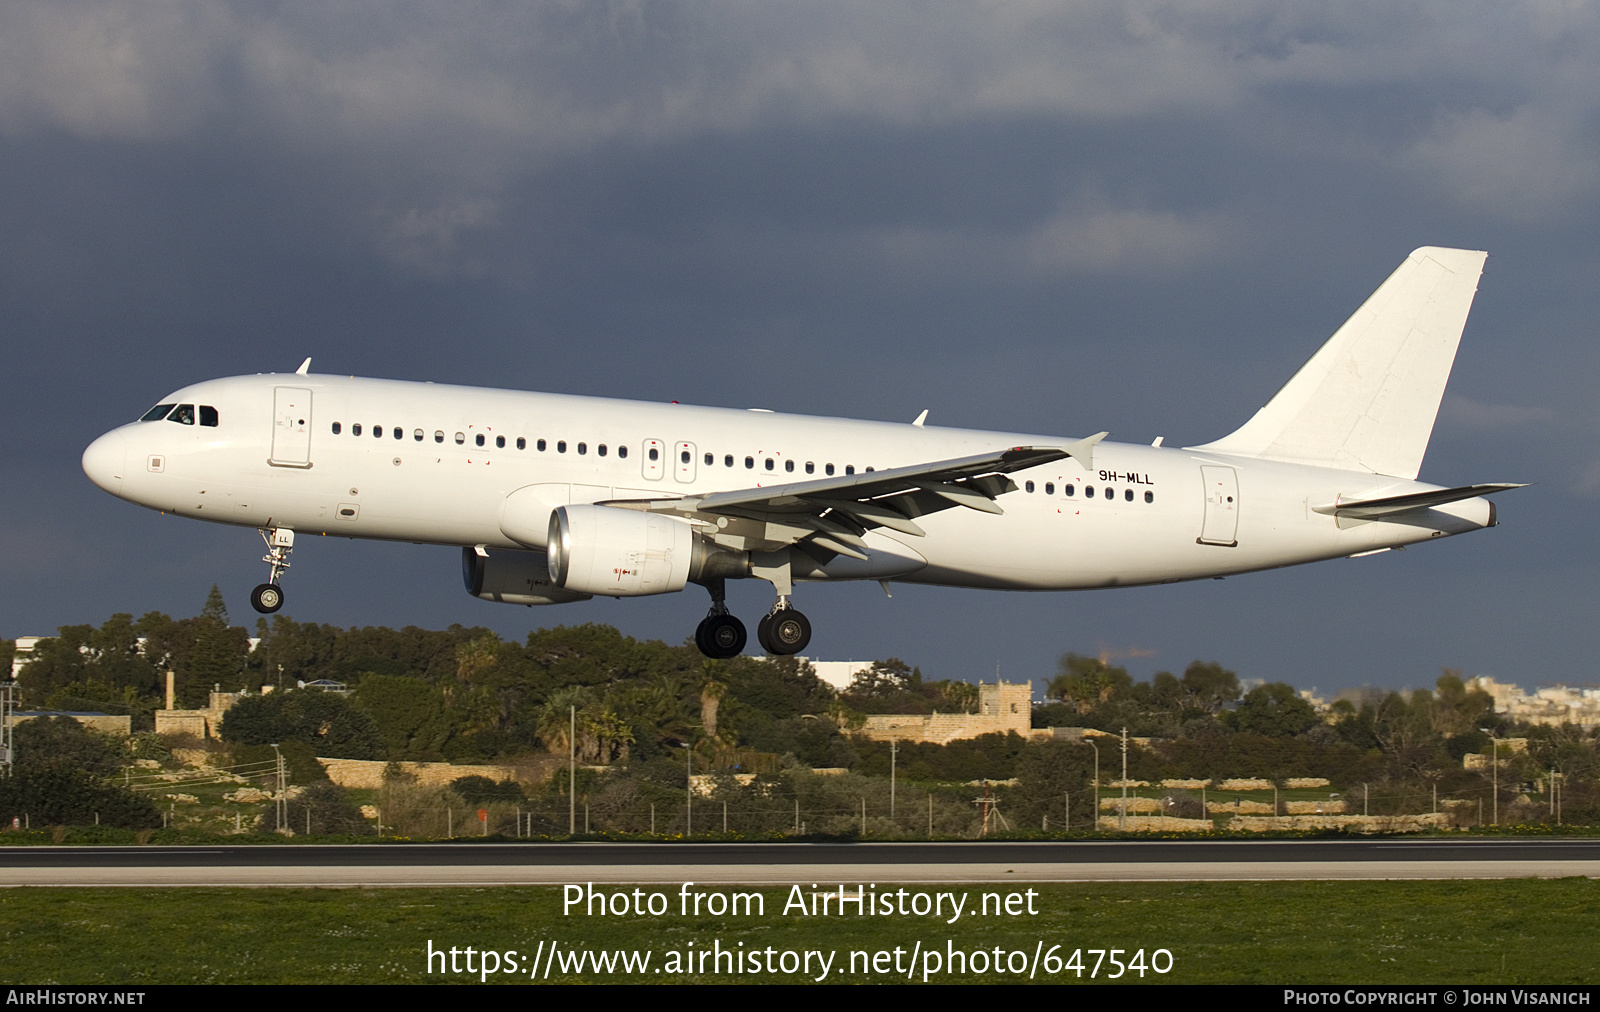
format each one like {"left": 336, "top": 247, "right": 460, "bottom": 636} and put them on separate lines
{"left": 85, "top": 375, "right": 1493, "bottom": 591}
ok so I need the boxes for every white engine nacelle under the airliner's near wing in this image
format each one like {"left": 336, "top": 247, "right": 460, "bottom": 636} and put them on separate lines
{"left": 549, "top": 504, "right": 720, "bottom": 597}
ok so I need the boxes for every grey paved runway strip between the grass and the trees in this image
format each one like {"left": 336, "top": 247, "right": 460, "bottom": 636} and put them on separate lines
{"left": 0, "top": 839, "right": 1600, "bottom": 887}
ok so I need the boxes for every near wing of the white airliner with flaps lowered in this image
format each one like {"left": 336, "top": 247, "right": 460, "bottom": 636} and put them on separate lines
{"left": 600, "top": 432, "right": 1107, "bottom": 559}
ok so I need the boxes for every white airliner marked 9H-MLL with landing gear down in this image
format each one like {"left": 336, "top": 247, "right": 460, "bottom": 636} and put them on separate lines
{"left": 83, "top": 247, "right": 1518, "bottom": 657}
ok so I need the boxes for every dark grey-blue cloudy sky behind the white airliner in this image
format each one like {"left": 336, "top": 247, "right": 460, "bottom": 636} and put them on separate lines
{"left": 0, "top": 0, "right": 1600, "bottom": 689}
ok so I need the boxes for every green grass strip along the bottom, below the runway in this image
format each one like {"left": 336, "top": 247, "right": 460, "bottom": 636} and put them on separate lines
{"left": 0, "top": 879, "right": 1600, "bottom": 985}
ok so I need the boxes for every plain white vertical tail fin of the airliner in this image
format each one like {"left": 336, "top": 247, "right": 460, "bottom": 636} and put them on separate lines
{"left": 1194, "top": 247, "right": 1488, "bottom": 479}
